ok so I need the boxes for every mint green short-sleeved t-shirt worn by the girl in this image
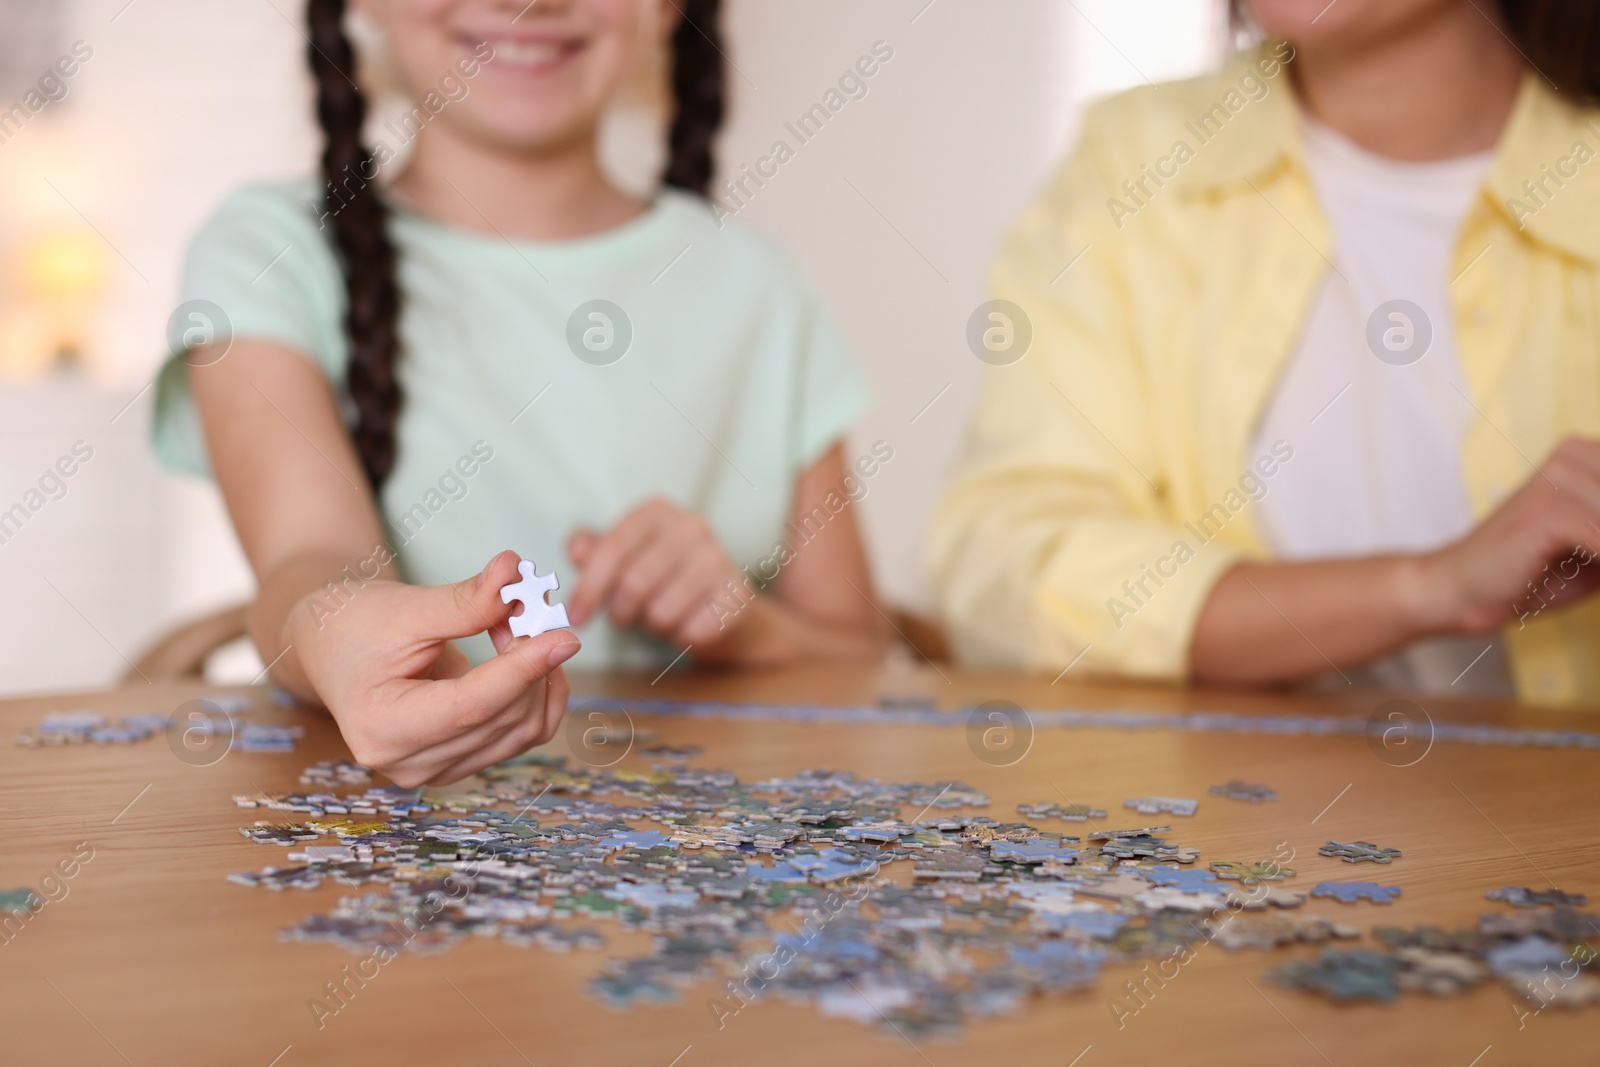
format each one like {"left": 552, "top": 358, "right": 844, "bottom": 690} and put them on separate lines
{"left": 152, "top": 181, "right": 870, "bottom": 667}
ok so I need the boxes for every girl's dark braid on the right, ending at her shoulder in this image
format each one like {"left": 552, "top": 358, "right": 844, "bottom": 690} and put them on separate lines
{"left": 664, "top": 0, "right": 726, "bottom": 197}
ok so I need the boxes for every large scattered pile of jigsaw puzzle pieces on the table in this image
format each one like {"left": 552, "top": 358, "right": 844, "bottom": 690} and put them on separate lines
{"left": 230, "top": 747, "right": 1600, "bottom": 1035}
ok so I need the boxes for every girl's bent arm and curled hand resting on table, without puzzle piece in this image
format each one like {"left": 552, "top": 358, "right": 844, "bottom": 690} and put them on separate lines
{"left": 568, "top": 446, "right": 888, "bottom": 664}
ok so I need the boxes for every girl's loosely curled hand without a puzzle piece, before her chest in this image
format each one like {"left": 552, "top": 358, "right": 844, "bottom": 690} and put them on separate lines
{"left": 566, "top": 498, "right": 757, "bottom": 654}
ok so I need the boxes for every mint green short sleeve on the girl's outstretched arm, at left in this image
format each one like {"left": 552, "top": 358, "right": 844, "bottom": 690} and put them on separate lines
{"left": 150, "top": 182, "right": 346, "bottom": 477}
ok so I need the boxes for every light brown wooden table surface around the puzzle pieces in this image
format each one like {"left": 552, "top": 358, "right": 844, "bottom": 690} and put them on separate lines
{"left": 0, "top": 667, "right": 1600, "bottom": 1067}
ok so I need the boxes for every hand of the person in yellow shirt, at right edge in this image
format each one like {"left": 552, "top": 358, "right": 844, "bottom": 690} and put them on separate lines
{"left": 1422, "top": 437, "right": 1600, "bottom": 633}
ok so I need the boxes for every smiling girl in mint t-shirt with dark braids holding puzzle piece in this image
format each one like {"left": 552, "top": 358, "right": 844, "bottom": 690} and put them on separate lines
{"left": 155, "top": 0, "right": 883, "bottom": 784}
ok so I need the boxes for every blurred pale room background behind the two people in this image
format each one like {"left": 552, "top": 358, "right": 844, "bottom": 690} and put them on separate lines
{"left": 0, "top": 0, "right": 1227, "bottom": 694}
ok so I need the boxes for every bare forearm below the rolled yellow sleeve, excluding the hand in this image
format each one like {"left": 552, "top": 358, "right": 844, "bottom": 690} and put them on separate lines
{"left": 1189, "top": 555, "right": 1456, "bottom": 685}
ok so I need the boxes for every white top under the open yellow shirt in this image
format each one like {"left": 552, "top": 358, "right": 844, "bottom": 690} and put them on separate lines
{"left": 1250, "top": 115, "right": 1512, "bottom": 696}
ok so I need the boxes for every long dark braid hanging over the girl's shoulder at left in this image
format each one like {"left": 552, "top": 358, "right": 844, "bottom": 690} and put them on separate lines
{"left": 307, "top": 0, "right": 402, "bottom": 493}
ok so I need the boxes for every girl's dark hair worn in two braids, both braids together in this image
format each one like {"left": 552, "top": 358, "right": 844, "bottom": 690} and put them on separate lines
{"left": 306, "top": 0, "right": 726, "bottom": 493}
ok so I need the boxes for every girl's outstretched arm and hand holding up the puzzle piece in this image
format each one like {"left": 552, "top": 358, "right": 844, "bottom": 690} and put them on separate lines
{"left": 189, "top": 339, "right": 578, "bottom": 785}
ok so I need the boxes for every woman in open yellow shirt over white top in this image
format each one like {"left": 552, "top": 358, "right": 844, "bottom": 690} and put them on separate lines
{"left": 931, "top": 0, "right": 1600, "bottom": 704}
